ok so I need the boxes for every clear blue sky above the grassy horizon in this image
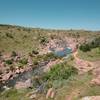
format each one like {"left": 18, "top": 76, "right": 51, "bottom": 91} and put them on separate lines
{"left": 0, "top": 0, "right": 100, "bottom": 30}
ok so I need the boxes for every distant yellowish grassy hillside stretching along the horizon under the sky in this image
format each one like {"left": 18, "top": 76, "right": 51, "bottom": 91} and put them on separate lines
{"left": 0, "top": 24, "right": 100, "bottom": 53}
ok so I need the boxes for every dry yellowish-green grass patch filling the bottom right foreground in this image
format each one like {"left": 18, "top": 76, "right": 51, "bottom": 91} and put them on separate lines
{"left": 55, "top": 73, "right": 100, "bottom": 100}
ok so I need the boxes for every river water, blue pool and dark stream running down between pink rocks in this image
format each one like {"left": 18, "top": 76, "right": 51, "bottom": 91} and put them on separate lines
{"left": 0, "top": 48, "right": 72, "bottom": 91}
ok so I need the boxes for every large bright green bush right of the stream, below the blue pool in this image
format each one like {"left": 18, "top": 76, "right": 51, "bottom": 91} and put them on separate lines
{"left": 43, "top": 63, "right": 77, "bottom": 80}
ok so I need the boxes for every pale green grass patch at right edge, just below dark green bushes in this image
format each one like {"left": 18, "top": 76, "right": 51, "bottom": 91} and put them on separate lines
{"left": 78, "top": 48, "right": 100, "bottom": 61}
